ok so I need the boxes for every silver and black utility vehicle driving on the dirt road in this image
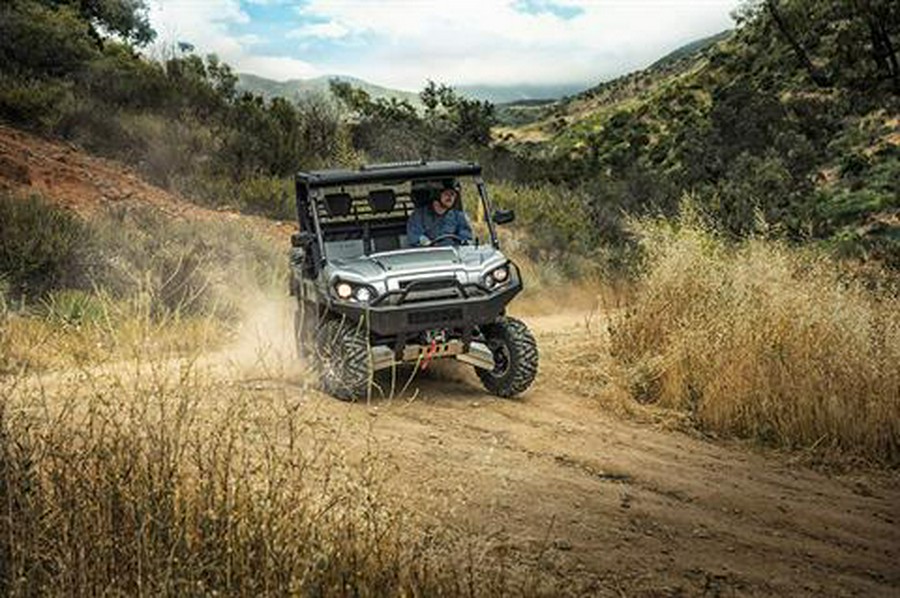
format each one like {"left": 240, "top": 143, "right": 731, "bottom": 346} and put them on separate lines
{"left": 290, "top": 161, "right": 538, "bottom": 401}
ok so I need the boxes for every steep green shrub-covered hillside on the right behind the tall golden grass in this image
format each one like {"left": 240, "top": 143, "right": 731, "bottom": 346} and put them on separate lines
{"left": 495, "top": 2, "right": 900, "bottom": 268}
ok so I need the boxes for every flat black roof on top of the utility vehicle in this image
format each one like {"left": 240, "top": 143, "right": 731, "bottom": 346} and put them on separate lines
{"left": 297, "top": 160, "right": 481, "bottom": 188}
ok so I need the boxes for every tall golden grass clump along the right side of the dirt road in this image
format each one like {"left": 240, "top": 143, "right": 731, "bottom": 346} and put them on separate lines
{"left": 611, "top": 211, "right": 900, "bottom": 466}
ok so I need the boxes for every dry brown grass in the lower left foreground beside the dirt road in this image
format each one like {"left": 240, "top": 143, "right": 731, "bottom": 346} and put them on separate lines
{"left": 0, "top": 340, "right": 560, "bottom": 596}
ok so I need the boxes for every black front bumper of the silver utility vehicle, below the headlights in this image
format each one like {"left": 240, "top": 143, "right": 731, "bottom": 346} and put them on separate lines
{"left": 331, "top": 280, "right": 522, "bottom": 336}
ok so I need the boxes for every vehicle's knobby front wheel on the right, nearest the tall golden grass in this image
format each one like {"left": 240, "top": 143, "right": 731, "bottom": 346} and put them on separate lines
{"left": 475, "top": 317, "right": 538, "bottom": 397}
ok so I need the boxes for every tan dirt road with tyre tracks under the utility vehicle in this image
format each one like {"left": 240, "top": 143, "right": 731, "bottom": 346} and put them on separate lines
{"left": 227, "top": 311, "right": 900, "bottom": 596}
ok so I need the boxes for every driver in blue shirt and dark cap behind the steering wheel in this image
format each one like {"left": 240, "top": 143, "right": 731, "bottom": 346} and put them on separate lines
{"left": 406, "top": 180, "right": 472, "bottom": 247}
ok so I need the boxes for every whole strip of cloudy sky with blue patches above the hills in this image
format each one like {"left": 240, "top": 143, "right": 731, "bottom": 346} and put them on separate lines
{"left": 148, "top": 0, "right": 739, "bottom": 91}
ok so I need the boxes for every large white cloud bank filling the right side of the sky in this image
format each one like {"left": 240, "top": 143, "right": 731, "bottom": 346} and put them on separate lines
{"left": 299, "top": 0, "right": 737, "bottom": 89}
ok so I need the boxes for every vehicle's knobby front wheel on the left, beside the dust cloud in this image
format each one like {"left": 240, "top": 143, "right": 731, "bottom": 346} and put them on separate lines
{"left": 315, "top": 319, "right": 371, "bottom": 401}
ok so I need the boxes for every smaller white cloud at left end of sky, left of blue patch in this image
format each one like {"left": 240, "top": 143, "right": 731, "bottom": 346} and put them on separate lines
{"left": 149, "top": 0, "right": 321, "bottom": 81}
